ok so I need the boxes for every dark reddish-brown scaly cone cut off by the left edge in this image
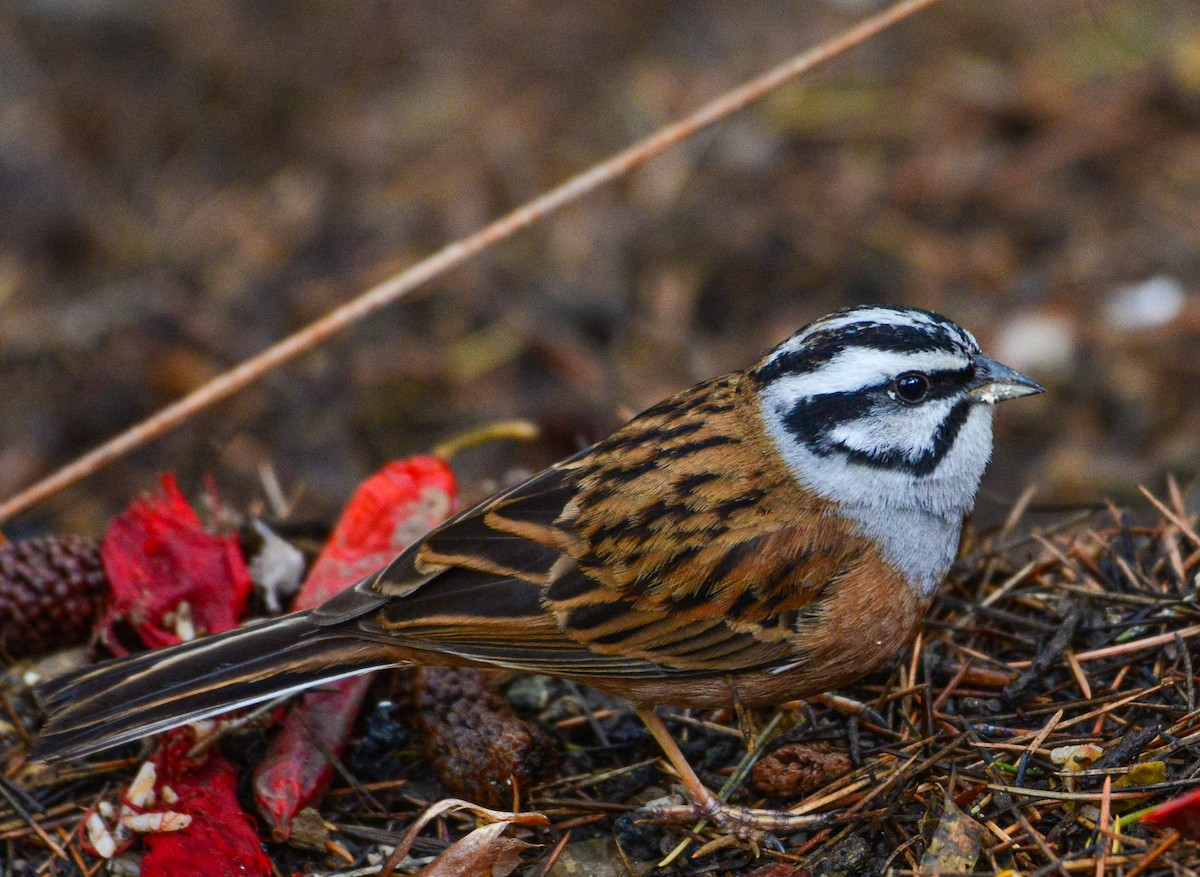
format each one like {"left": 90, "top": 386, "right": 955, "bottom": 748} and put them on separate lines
{"left": 0, "top": 536, "right": 108, "bottom": 657}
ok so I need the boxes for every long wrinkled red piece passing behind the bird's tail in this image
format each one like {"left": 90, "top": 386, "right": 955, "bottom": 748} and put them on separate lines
{"left": 254, "top": 456, "right": 457, "bottom": 840}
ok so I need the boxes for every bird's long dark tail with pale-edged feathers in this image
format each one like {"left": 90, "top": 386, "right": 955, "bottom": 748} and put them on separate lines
{"left": 32, "top": 612, "right": 397, "bottom": 761}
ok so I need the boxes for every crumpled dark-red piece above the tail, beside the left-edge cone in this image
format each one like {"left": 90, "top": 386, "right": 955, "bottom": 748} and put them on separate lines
{"left": 100, "top": 474, "right": 252, "bottom": 655}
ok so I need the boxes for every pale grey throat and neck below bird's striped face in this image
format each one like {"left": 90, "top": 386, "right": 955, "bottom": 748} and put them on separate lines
{"left": 761, "top": 388, "right": 992, "bottom": 596}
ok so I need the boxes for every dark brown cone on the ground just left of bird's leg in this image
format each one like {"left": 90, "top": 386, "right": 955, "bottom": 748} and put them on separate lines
{"left": 413, "top": 667, "right": 558, "bottom": 810}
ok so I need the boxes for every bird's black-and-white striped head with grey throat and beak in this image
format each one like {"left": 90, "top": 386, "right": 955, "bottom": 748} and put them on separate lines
{"left": 751, "top": 306, "right": 1042, "bottom": 590}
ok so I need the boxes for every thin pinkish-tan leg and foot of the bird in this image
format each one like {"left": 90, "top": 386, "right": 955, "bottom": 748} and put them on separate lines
{"left": 637, "top": 707, "right": 826, "bottom": 840}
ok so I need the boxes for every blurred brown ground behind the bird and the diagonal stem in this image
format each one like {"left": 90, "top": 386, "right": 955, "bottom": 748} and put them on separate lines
{"left": 0, "top": 0, "right": 1200, "bottom": 537}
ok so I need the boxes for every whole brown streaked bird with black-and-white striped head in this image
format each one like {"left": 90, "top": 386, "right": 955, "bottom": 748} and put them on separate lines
{"left": 32, "top": 305, "right": 1043, "bottom": 833}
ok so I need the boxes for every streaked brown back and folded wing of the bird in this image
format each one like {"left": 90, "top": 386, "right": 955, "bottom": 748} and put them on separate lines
{"left": 319, "top": 376, "right": 853, "bottom": 678}
